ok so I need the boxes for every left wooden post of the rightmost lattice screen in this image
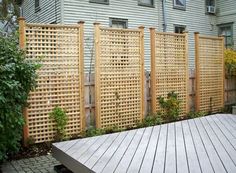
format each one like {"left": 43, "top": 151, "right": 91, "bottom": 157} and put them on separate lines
{"left": 194, "top": 32, "right": 200, "bottom": 112}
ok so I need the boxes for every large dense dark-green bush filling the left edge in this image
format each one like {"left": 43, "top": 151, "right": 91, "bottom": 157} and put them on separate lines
{"left": 0, "top": 33, "right": 39, "bottom": 161}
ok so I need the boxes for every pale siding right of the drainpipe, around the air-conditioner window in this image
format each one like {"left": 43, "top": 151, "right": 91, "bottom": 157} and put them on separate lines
{"left": 158, "top": 0, "right": 217, "bottom": 69}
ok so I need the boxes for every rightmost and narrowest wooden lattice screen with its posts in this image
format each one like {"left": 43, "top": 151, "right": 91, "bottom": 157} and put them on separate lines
{"left": 195, "top": 33, "right": 224, "bottom": 113}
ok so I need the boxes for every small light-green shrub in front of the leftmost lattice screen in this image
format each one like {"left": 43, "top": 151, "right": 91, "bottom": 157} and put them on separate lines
{"left": 49, "top": 107, "right": 68, "bottom": 141}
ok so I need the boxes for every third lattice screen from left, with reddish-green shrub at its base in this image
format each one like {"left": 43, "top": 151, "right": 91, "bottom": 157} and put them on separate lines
{"left": 150, "top": 28, "right": 189, "bottom": 116}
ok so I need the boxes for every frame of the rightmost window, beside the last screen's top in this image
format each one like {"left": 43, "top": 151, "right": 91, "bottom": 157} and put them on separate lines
{"left": 217, "top": 22, "right": 234, "bottom": 48}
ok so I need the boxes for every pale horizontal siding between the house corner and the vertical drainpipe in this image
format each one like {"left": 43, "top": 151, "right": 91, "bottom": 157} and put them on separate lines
{"left": 63, "top": 0, "right": 158, "bottom": 71}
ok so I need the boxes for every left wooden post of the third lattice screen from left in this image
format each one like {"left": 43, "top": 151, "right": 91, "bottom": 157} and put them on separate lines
{"left": 149, "top": 28, "right": 157, "bottom": 114}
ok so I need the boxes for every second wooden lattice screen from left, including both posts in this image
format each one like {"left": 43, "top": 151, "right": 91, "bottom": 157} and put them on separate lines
{"left": 95, "top": 24, "right": 144, "bottom": 128}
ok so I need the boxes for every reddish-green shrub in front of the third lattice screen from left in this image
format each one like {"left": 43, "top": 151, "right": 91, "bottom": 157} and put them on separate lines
{"left": 158, "top": 91, "right": 180, "bottom": 121}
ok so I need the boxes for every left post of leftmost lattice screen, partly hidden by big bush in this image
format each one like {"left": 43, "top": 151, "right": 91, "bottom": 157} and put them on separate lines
{"left": 18, "top": 17, "right": 29, "bottom": 146}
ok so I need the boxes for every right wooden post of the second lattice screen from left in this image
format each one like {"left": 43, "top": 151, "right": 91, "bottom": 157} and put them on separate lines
{"left": 139, "top": 26, "right": 145, "bottom": 120}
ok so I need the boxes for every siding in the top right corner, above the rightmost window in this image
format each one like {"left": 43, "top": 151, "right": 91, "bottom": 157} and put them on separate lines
{"left": 217, "top": 0, "right": 236, "bottom": 49}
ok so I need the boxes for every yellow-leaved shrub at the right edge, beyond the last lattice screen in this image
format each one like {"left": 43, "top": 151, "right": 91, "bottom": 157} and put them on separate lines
{"left": 224, "top": 49, "right": 236, "bottom": 75}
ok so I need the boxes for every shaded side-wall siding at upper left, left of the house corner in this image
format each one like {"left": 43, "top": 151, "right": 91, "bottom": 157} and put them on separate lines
{"left": 22, "top": 0, "right": 61, "bottom": 23}
